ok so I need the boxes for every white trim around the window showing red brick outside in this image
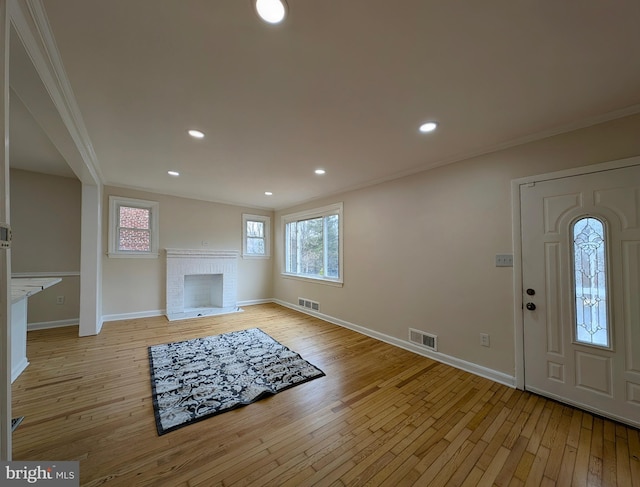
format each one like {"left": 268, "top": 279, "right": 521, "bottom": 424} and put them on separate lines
{"left": 107, "top": 196, "right": 160, "bottom": 259}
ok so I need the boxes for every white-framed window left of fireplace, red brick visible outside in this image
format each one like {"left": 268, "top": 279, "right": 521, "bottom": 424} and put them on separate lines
{"left": 109, "top": 196, "right": 159, "bottom": 257}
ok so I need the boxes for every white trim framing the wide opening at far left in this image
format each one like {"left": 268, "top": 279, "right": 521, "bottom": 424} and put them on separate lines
{"left": 0, "top": 0, "right": 103, "bottom": 460}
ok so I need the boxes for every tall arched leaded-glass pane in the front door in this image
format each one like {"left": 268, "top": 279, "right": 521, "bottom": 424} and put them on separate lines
{"left": 572, "top": 217, "right": 611, "bottom": 348}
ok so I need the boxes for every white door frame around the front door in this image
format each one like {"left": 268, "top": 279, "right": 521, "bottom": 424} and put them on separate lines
{"left": 511, "top": 156, "right": 640, "bottom": 390}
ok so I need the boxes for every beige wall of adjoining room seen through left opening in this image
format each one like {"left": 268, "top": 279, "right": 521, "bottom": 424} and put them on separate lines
{"left": 10, "top": 169, "right": 82, "bottom": 323}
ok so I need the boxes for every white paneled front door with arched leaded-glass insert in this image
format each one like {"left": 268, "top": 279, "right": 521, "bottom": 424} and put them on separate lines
{"left": 520, "top": 166, "right": 640, "bottom": 427}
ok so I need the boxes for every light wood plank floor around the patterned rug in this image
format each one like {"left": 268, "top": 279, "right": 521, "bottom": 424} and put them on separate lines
{"left": 13, "top": 304, "right": 640, "bottom": 487}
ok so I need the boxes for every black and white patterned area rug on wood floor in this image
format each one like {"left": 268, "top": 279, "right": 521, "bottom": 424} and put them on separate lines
{"left": 149, "top": 328, "right": 325, "bottom": 435}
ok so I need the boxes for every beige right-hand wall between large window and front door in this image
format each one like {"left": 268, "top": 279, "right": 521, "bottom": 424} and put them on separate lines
{"left": 273, "top": 115, "right": 640, "bottom": 376}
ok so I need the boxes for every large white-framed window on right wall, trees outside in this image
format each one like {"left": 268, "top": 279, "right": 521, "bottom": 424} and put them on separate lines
{"left": 282, "top": 203, "right": 342, "bottom": 283}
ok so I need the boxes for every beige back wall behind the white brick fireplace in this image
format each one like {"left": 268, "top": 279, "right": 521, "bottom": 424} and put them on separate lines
{"left": 102, "top": 186, "right": 273, "bottom": 318}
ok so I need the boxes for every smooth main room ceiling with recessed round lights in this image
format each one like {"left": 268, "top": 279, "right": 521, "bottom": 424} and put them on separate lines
{"left": 11, "top": 0, "right": 640, "bottom": 209}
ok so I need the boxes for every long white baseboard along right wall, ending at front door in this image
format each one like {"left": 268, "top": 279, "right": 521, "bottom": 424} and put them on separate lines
{"left": 272, "top": 299, "right": 516, "bottom": 387}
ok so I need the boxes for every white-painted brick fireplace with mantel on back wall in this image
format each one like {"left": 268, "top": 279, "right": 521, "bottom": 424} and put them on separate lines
{"left": 166, "top": 249, "right": 240, "bottom": 321}
